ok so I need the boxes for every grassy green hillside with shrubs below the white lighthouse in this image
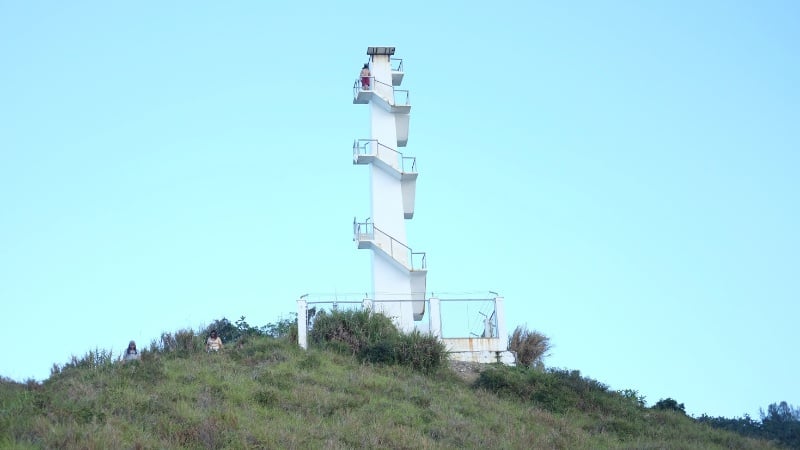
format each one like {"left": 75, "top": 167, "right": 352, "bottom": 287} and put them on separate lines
{"left": 0, "top": 313, "right": 779, "bottom": 449}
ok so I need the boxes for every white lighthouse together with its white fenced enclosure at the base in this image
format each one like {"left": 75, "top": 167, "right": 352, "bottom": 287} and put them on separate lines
{"left": 297, "top": 47, "right": 515, "bottom": 364}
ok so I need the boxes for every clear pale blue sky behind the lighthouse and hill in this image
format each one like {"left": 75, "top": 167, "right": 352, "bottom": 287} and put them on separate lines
{"left": 0, "top": 0, "right": 800, "bottom": 417}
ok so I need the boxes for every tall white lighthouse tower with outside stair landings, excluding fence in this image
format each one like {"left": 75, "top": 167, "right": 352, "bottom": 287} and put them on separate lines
{"left": 353, "top": 47, "right": 427, "bottom": 332}
